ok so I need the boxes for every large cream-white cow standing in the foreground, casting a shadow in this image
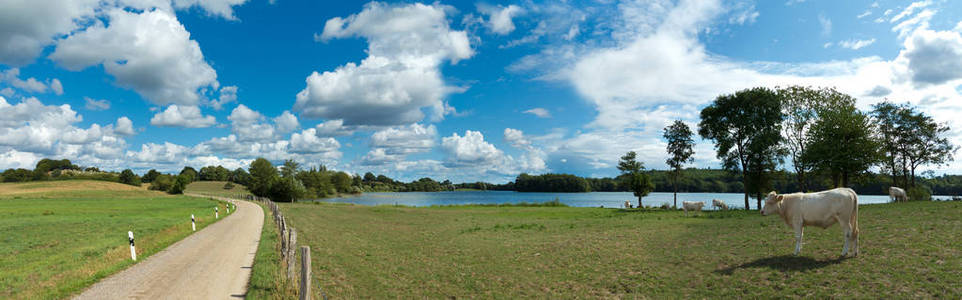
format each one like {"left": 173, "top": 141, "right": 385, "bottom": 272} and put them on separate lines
{"left": 762, "top": 188, "right": 858, "bottom": 257}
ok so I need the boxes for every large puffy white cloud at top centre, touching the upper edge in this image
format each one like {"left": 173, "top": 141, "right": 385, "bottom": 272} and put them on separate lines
{"left": 294, "top": 2, "right": 474, "bottom": 126}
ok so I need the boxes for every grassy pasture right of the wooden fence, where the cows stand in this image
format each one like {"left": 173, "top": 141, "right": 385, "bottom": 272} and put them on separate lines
{"left": 281, "top": 202, "right": 962, "bottom": 299}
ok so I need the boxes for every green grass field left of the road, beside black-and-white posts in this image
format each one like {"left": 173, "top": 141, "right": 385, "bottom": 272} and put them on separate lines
{"left": 0, "top": 180, "right": 232, "bottom": 299}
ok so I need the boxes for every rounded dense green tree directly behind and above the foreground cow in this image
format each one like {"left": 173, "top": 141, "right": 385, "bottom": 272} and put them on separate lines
{"left": 801, "top": 101, "right": 879, "bottom": 187}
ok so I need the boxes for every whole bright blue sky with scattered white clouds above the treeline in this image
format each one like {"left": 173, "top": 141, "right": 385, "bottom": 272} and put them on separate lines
{"left": 0, "top": 0, "right": 962, "bottom": 182}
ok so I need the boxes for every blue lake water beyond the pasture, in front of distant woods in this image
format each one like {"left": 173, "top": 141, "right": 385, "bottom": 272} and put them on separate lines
{"left": 318, "top": 191, "right": 947, "bottom": 209}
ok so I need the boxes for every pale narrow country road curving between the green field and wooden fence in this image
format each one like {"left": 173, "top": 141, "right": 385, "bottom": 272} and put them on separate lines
{"left": 74, "top": 195, "right": 264, "bottom": 300}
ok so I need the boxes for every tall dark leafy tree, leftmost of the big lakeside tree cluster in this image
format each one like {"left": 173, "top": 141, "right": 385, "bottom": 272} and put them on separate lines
{"left": 698, "top": 87, "right": 784, "bottom": 209}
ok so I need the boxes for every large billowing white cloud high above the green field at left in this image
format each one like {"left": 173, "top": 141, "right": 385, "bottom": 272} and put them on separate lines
{"left": 50, "top": 9, "right": 218, "bottom": 106}
